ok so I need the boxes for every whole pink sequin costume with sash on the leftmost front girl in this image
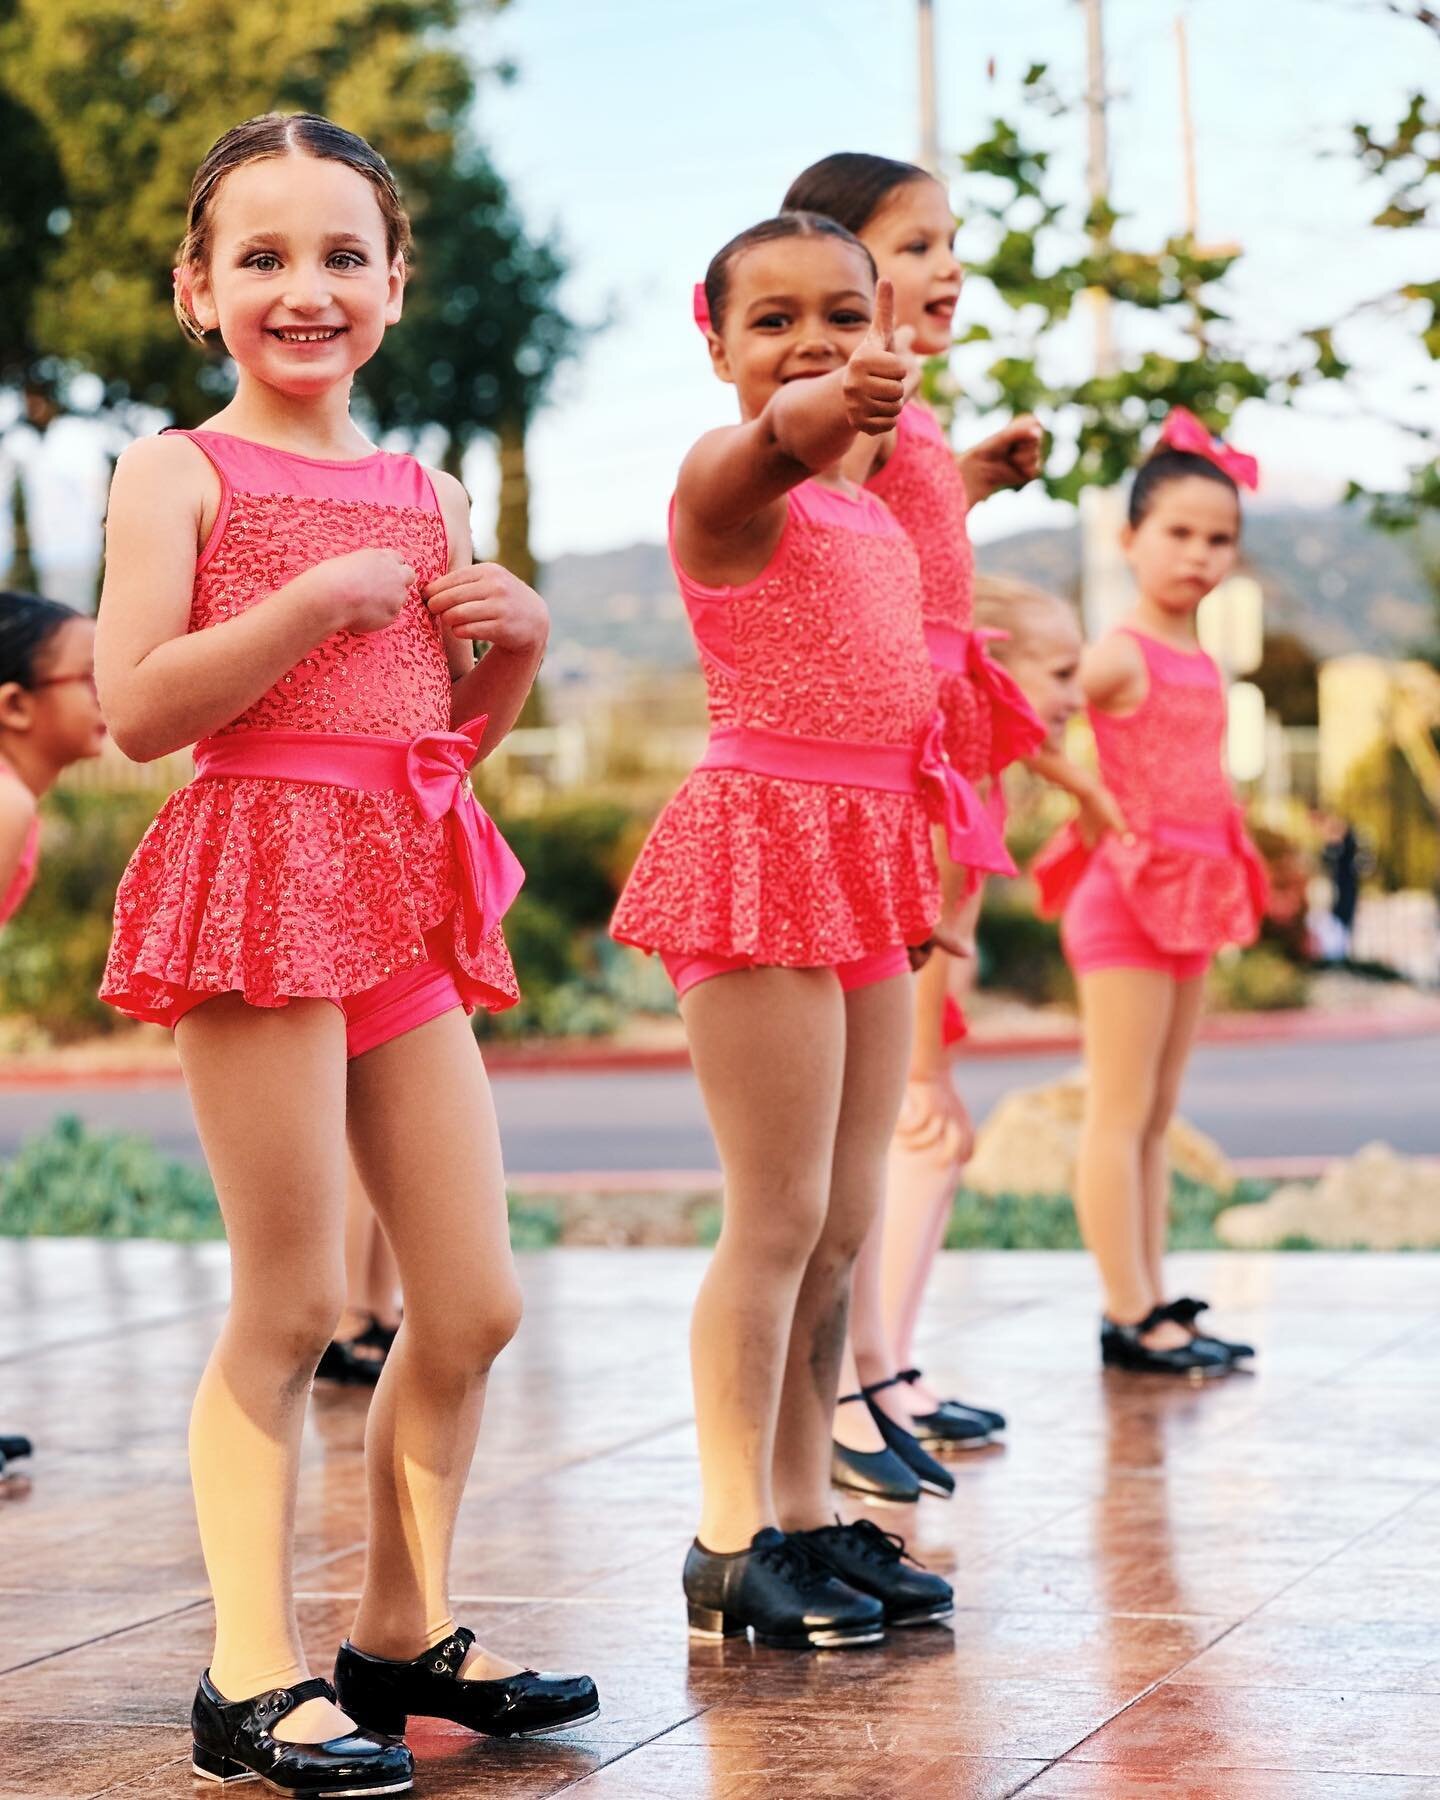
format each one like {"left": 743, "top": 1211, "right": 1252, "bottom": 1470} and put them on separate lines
{"left": 101, "top": 430, "right": 520, "bottom": 1055}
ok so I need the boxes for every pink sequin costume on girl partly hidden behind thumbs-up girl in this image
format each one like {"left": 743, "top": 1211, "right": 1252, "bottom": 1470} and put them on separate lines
{"left": 868, "top": 400, "right": 1046, "bottom": 781}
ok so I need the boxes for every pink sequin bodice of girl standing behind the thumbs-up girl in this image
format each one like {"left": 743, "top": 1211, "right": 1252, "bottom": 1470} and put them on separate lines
{"left": 868, "top": 400, "right": 976, "bottom": 630}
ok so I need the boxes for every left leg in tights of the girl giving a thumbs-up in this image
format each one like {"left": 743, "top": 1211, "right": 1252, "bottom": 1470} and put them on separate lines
{"left": 684, "top": 968, "right": 846, "bottom": 1552}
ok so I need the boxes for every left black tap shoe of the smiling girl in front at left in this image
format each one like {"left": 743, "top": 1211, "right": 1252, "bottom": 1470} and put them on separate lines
{"left": 191, "top": 1669, "right": 416, "bottom": 1800}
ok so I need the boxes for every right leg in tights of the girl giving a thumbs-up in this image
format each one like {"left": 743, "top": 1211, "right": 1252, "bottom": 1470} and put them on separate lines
{"left": 774, "top": 976, "right": 913, "bottom": 1532}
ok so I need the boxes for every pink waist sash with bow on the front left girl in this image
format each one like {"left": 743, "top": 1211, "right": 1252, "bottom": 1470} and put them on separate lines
{"left": 194, "top": 718, "right": 526, "bottom": 956}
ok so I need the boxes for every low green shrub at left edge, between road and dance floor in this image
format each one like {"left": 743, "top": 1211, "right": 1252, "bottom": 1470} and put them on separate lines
{"left": 0, "top": 1116, "right": 225, "bottom": 1242}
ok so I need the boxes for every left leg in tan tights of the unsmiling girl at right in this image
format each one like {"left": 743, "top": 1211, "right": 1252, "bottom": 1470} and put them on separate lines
{"left": 1075, "top": 968, "right": 1175, "bottom": 1325}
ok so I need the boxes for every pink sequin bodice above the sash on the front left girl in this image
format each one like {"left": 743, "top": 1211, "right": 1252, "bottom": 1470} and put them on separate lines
{"left": 187, "top": 432, "right": 450, "bottom": 738}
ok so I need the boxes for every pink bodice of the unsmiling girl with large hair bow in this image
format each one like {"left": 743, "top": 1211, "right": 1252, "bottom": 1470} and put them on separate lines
{"left": 1089, "top": 632, "right": 1235, "bottom": 832}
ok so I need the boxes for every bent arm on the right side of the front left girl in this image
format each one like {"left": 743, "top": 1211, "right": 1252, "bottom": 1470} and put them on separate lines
{"left": 425, "top": 472, "right": 549, "bottom": 760}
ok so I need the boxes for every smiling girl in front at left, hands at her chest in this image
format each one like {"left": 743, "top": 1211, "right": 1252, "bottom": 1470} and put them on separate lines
{"left": 97, "top": 113, "right": 596, "bottom": 1795}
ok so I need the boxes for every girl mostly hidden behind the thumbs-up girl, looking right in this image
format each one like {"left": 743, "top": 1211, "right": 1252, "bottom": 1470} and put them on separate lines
{"left": 785, "top": 153, "right": 1116, "bottom": 1501}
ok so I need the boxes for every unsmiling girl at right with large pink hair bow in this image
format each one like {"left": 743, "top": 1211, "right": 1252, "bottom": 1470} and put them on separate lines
{"left": 1035, "top": 409, "right": 1265, "bottom": 1375}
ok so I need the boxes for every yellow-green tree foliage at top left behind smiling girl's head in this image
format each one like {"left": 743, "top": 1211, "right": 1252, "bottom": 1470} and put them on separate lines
{"left": 0, "top": 0, "right": 473, "bottom": 423}
